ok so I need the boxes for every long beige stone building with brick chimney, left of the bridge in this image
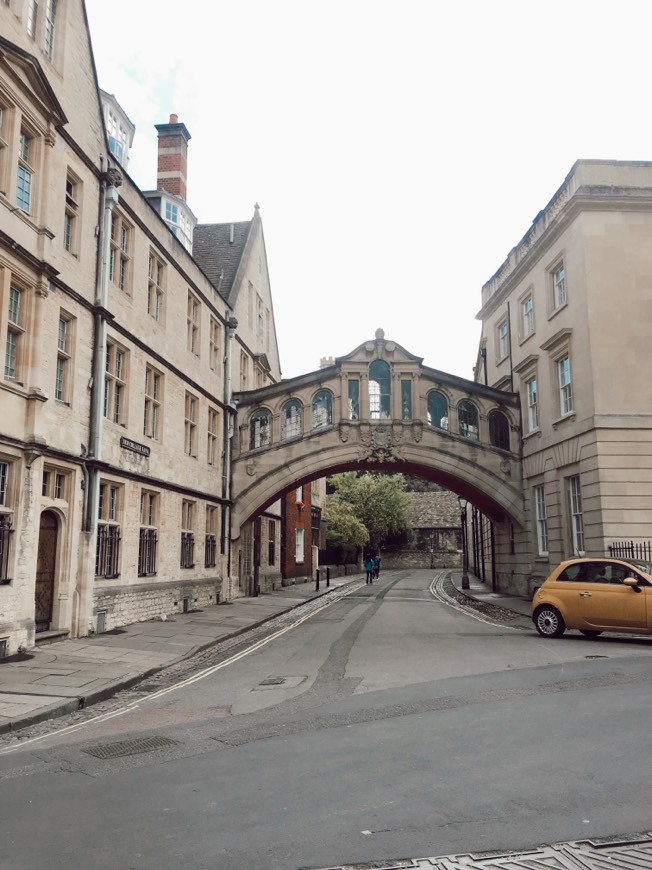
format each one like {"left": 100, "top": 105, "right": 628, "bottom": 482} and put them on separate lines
{"left": 0, "top": 0, "right": 280, "bottom": 654}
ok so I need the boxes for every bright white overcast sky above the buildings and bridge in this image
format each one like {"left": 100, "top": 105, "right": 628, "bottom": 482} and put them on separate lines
{"left": 86, "top": 0, "right": 652, "bottom": 378}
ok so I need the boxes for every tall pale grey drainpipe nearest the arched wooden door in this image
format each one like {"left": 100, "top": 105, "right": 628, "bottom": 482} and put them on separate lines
{"left": 80, "top": 167, "right": 122, "bottom": 634}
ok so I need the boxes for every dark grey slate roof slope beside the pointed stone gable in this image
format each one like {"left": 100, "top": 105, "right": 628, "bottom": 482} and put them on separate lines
{"left": 192, "top": 221, "right": 252, "bottom": 301}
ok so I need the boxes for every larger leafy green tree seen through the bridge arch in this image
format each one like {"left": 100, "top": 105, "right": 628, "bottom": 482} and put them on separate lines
{"left": 330, "top": 471, "right": 408, "bottom": 552}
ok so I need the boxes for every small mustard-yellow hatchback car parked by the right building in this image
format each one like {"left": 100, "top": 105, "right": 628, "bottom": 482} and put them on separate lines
{"left": 532, "top": 559, "right": 652, "bottom": 637}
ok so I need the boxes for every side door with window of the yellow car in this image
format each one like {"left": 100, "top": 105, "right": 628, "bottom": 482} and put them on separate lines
{"left": 579, "top": 561, "right": 648, "bottom": 631}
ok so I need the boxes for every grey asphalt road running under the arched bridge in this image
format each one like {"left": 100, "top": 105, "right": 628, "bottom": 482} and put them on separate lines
{"left": 0, "top": 571, "right": 652, "bottom": 870}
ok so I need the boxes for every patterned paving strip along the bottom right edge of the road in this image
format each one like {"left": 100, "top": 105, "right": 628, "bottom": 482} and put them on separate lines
{"left": 308, "top": 832, "right": 652, "bottom": 870}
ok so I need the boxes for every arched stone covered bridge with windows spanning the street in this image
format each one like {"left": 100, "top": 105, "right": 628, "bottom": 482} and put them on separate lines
{"left": 231, "top": 329, "right": 523, "bottom": 539}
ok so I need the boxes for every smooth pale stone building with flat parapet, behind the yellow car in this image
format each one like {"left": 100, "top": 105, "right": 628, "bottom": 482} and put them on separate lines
{"left": 475, "top": 160, "right": 652, "bottom": 593}
